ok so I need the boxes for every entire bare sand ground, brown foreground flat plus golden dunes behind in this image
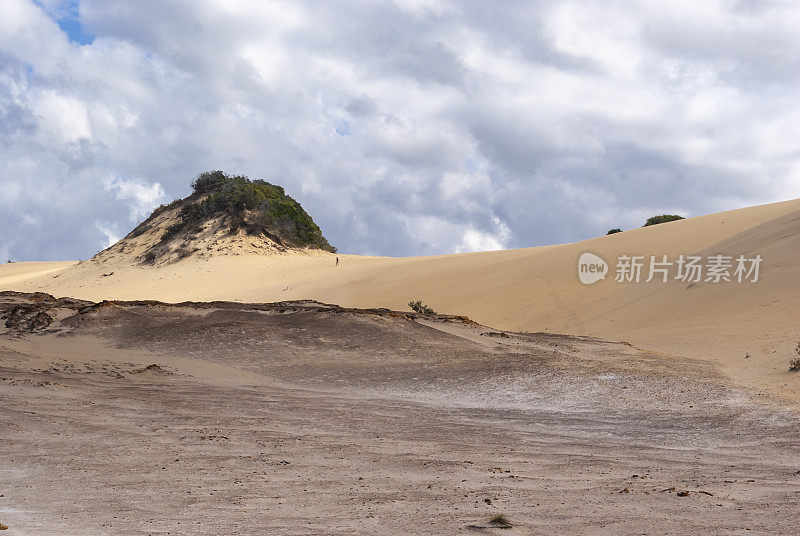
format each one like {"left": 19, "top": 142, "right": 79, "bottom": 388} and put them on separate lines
{"left": 0, "top": 200, "right": 800, "bottom": 535}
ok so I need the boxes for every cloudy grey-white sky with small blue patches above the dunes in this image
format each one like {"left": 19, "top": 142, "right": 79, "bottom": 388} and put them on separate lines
{"left": 0, "top": 0, "right": 800, "bottom": 260}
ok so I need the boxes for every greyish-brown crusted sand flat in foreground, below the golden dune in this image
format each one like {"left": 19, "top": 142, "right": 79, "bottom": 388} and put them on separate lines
{"left": 0, "top": 294, "right": 800, "bottom": 535}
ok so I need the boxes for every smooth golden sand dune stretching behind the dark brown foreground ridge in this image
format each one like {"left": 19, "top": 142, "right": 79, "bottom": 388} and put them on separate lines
{"left": 0, "top": 200, "right": 800, "bottom": 400}
